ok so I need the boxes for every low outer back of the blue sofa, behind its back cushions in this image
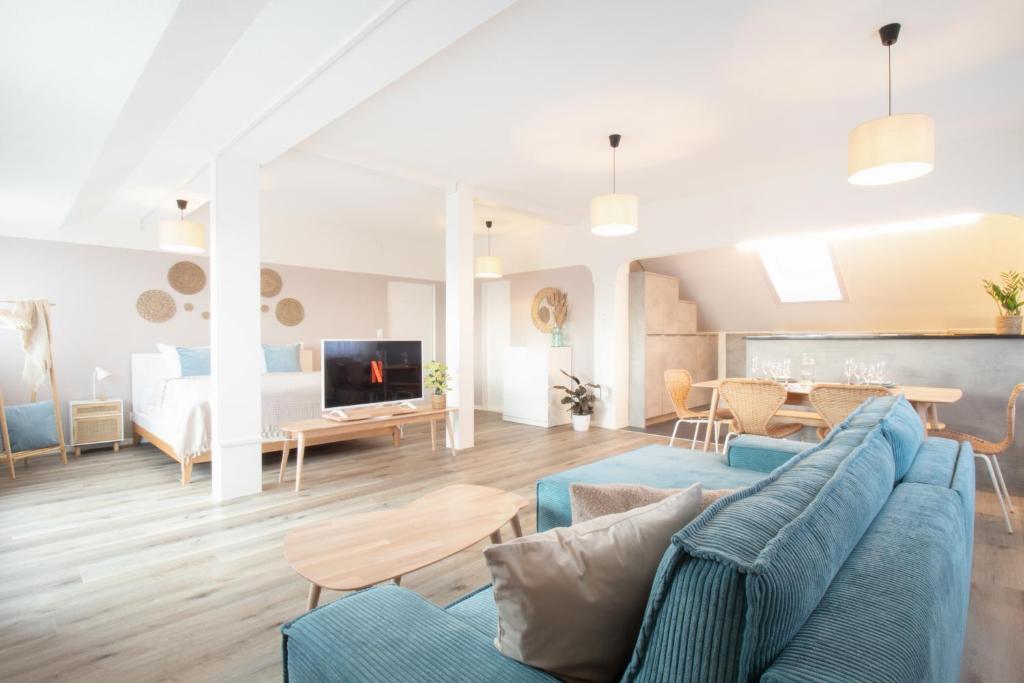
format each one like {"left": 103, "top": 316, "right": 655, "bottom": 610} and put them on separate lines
{"left": 761, "top": 482, "right": 971, "bottom": 683}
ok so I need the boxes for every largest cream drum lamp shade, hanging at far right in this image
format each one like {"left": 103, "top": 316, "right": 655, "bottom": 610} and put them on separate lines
{"left": 847, "top": 114, "right": 935, "bottom": 185}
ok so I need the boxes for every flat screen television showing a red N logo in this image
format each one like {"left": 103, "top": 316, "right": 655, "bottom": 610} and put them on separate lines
{"left": 321, "top": 339, "right": 423, "bottom": 412}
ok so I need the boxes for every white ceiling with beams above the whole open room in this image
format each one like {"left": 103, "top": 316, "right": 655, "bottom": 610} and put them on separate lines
{"left": 0, "top": 0, "right": 1024, "bottom": 274}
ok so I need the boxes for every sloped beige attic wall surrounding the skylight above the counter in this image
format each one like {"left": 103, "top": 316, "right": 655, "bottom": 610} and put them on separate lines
{"left": 642, "top": 211, "right": 1024, "bottom": 332}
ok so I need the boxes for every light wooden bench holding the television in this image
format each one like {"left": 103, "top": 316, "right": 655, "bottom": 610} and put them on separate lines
{"left": 278, "top": 408, "right": 456, "bottom": 492}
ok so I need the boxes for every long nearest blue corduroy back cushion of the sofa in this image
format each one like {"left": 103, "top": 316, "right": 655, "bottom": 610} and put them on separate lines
{"left": 624, "top": 413, "right": 895, "bottom": 681}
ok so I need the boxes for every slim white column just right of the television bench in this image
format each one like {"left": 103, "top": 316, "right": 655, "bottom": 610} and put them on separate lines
{"left": 444, "top": 183, "right": 475, "bottom": 450}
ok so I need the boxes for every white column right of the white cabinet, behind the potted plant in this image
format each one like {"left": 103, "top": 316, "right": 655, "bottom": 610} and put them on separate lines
{"left": 593, "top": 263, "right": 630, "bottom": 429}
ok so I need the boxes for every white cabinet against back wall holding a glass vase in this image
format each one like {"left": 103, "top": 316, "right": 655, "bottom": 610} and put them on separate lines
{"left": 502, "top": 346, "right": 572, "bottom": 427}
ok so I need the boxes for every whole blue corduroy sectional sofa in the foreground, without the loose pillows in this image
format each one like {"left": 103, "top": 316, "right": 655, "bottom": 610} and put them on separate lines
{"left": 283, "top": 396, "right": 974, "bottom": 683}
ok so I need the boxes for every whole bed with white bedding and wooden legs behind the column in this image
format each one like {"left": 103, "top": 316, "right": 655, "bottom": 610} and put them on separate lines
{"left": 131, "top": 349, "right": 391, "bottom": 484}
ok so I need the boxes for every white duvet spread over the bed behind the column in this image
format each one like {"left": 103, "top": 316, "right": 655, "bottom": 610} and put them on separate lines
{"left": 143, "top": 373, "right": 321, "bottom": 460}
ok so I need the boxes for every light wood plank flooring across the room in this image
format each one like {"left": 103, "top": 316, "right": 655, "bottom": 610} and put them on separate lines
{"left": 0, "top": 413, "right": 1024, "bottom": 682}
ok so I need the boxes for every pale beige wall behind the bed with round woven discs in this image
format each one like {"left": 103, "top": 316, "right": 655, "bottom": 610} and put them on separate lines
{"left": 0, "top": 238, "right": 444, "bottom": 419}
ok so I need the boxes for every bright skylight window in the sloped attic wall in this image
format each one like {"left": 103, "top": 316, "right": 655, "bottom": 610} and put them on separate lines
{"left": 756, "top": 239, "right": 843, "bottom": 303}
